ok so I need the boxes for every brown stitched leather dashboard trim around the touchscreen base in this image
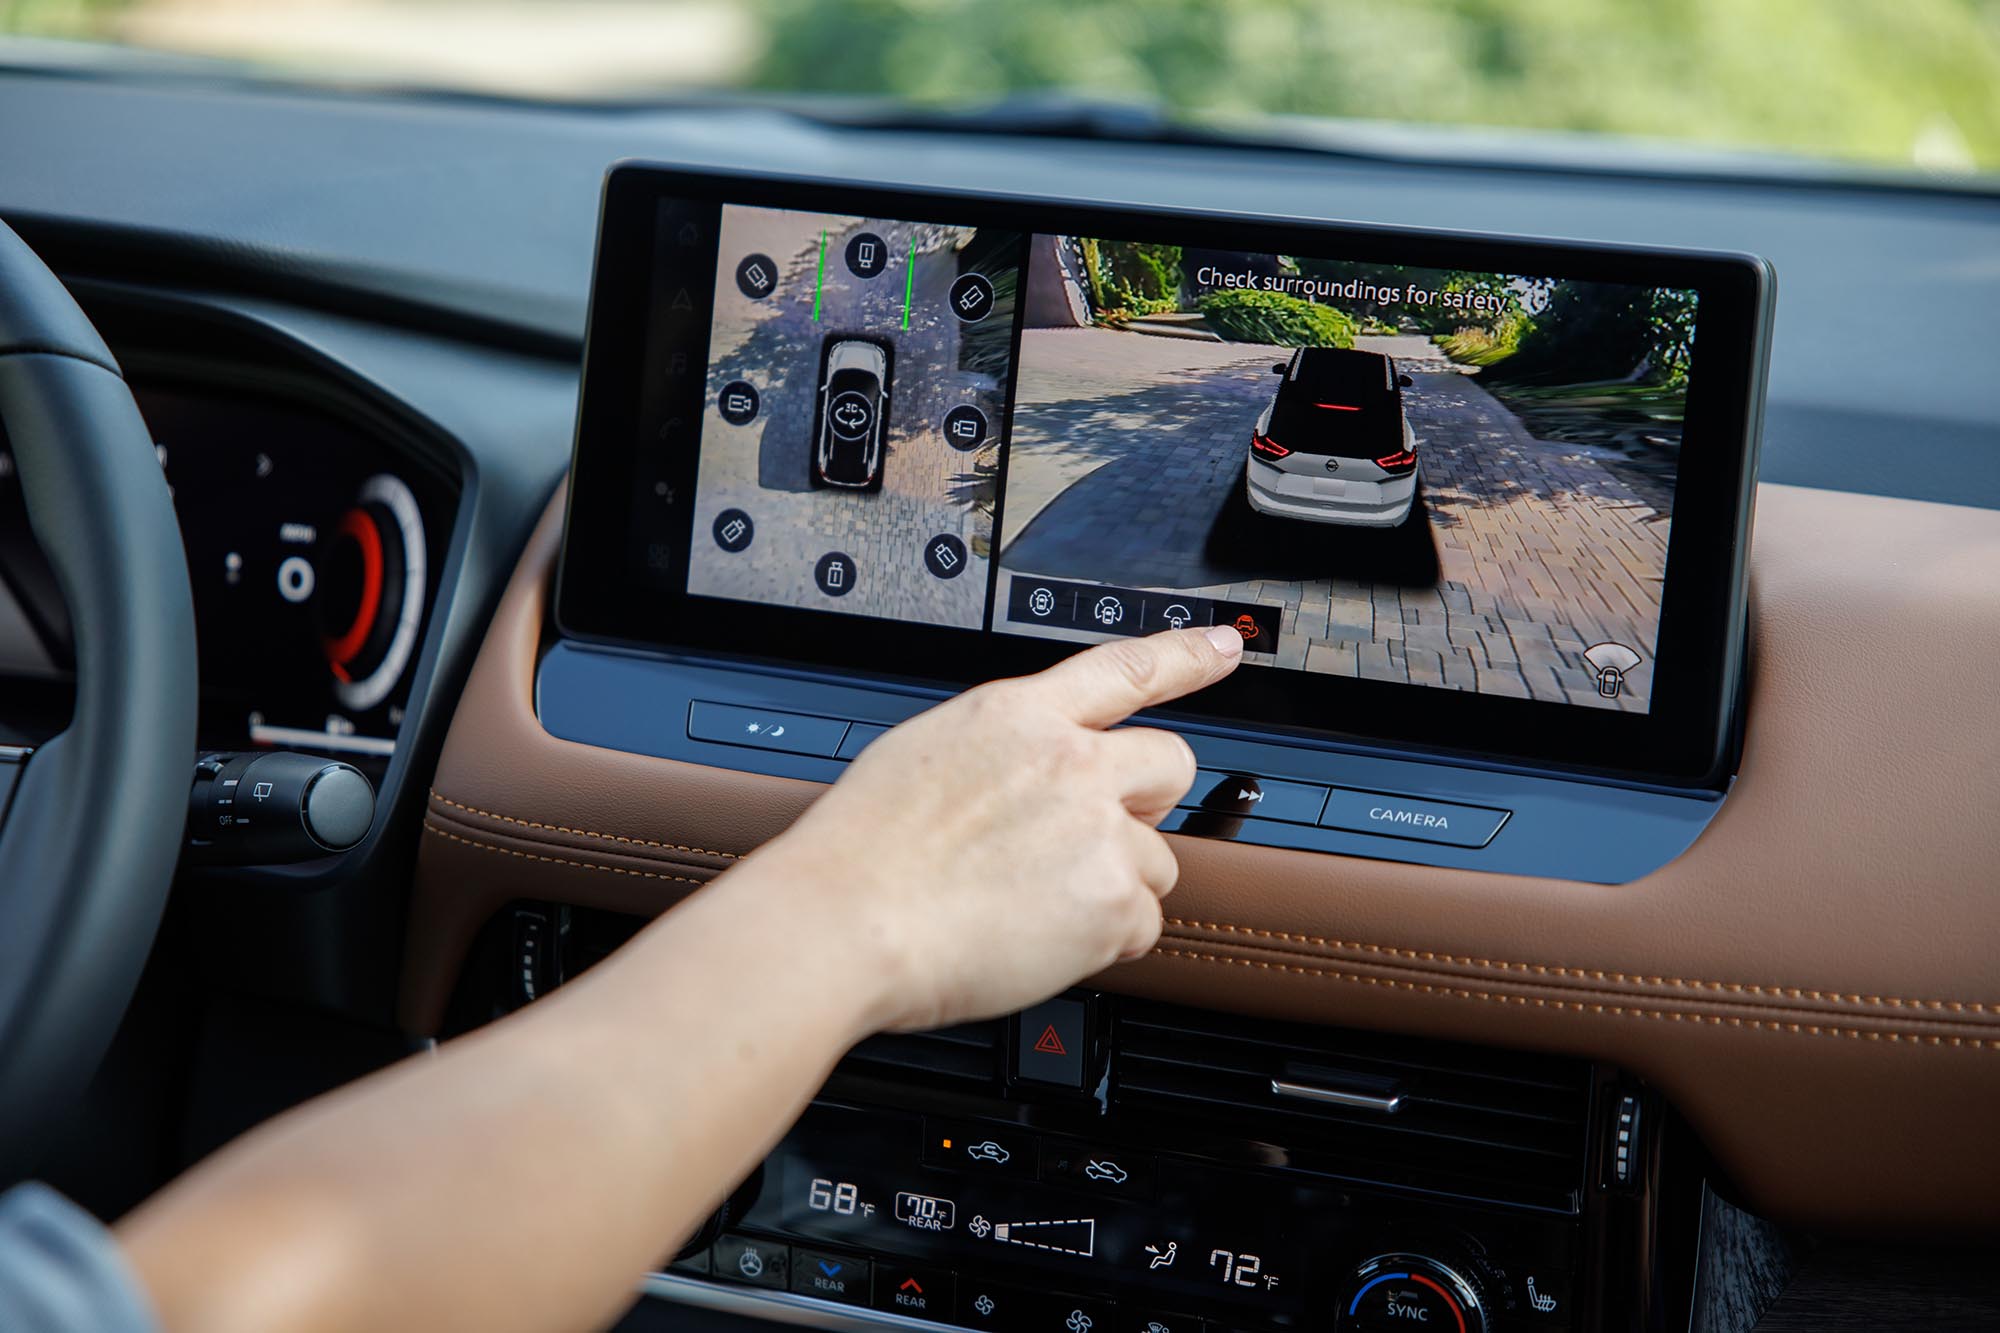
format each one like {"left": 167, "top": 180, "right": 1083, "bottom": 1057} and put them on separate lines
{"left": 402, "top": 486, "right": 2000, "bottom": 1231}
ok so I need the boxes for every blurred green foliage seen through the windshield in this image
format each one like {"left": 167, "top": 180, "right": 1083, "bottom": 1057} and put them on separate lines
{"left": 752, "top": 0, "right": 2000, "bottom": 170}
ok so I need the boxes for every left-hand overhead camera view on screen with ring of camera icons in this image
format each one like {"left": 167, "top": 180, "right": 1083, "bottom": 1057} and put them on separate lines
{"left": 688, "top": 204, "right": 1022, "bottom": 628}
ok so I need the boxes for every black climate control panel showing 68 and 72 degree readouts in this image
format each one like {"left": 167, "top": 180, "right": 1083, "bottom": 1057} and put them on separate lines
{"left": 674, "top": 1103, "right": 1572, "bottom": 1333}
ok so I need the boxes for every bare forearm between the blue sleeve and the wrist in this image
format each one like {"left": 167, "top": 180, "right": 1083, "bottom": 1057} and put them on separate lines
{"left": 120, "top": 849, "right": 884, "bottom": 1333}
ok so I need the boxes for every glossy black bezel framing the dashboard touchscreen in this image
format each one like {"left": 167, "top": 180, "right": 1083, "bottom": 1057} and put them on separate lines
{"left": 556, "top": 164, "right": 1772, "bottom": 787}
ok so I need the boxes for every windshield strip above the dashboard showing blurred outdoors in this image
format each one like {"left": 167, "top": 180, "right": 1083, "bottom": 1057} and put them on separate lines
{"left": 0, "top": 0, "right": 2000, "bottom": 172}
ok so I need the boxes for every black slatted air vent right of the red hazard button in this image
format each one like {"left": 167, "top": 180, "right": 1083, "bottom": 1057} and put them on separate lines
{"left": 1112, "top": 1001, "right": 1590, "bottom": 1211}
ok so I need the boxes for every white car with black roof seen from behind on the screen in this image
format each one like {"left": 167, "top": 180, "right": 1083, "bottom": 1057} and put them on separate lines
{"left": 1244, "top": 346, "right": 1418, "bottom": 528}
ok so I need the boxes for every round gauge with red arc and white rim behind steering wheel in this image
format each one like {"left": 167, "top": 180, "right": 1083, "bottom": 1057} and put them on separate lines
{"left": 316, "top": 472, "right": 426, "bottom": 713}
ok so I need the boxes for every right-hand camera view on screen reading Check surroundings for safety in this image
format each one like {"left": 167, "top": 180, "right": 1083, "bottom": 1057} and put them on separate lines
{"left": 994, "top": 236, "right": 1694, "bottom": 713}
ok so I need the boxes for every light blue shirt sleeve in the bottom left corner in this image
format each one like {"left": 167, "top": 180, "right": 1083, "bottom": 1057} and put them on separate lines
{"left": 0, "top": 1183, "right": 160, "bottom": 1333}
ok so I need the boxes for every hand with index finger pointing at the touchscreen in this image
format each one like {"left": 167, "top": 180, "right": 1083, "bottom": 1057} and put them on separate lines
{"left": 752, "top": 626, "right": 1242, "bottom": 1029}
